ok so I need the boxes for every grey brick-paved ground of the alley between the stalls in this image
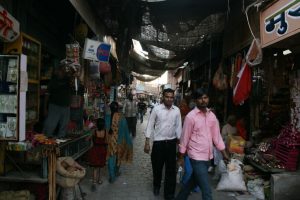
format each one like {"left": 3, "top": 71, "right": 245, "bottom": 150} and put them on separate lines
{"left": 80, "top": 110, "right": 235, "bottom": 200}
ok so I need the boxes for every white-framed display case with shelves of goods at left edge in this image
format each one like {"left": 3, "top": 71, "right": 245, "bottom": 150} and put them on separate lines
{"left": 0, "top": 55, "right": 26, "bottom": 141}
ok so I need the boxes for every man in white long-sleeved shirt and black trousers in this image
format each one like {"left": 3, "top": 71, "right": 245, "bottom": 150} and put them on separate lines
{"left": 144, "top": 89, "right": 182, "bottom": 200}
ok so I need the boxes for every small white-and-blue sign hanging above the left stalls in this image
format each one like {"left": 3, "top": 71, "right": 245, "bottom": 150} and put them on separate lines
{"left": 83, "top": 38, "right": 111, "bottom": 62}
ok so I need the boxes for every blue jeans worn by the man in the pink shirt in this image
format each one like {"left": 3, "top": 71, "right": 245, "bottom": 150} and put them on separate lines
{"left": 176, "top": 158, "right": 212, "bottom": 200}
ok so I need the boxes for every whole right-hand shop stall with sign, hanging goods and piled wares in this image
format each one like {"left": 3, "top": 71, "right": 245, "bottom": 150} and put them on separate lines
{"left": 214, "top": 0, "right": 300, "bottom": 200}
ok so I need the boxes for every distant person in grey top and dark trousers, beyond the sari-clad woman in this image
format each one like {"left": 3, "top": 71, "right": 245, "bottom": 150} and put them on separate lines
{"left": 123, "top": 93, "right": 137, "bottom": 137}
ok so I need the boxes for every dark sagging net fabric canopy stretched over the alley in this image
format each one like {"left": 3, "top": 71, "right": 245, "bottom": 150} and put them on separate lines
{"left": 82, "top": 0, "right": 228, "bottom": 80}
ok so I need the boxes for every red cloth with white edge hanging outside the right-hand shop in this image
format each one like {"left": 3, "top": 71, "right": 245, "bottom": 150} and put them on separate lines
{"left": 233, "top": 63, "right": 252, "bottom": 105}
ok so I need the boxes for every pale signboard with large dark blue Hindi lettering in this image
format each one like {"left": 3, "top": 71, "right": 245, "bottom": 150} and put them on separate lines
{"left": 260, "top": 0, "right": 300, "bottom": 47}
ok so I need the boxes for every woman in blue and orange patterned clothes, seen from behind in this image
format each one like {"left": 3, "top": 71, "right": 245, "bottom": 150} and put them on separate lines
{"left": 105, "top": 101, "right": 133, "bottom": 183}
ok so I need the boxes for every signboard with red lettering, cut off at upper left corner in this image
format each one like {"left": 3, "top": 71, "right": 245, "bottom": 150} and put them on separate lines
{"left": 0, "top": 5, "right": 20, "bottom": 42}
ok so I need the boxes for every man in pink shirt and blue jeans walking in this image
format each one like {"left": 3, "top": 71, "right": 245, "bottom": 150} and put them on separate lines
{"left": 176, "top": 89, "right": 228, "bottom": 200}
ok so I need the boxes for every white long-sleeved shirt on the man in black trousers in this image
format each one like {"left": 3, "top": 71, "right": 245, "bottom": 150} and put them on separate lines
{"left": 145, "top": 103, "right": 182, "bottom": 141}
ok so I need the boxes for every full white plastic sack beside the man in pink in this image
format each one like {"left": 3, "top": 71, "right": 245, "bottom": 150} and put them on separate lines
{"left": 217, "top": 159, "right": 247, "bottom": 191}
